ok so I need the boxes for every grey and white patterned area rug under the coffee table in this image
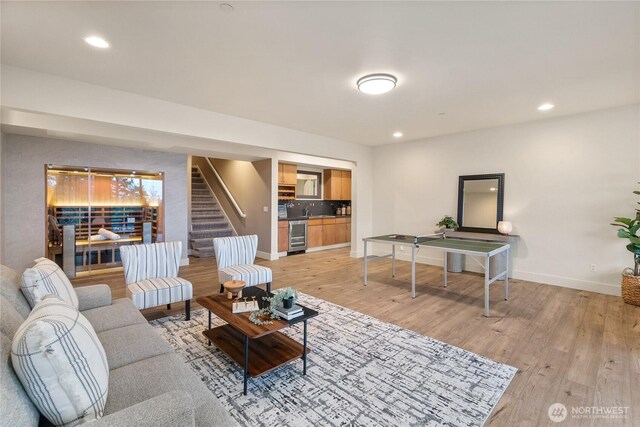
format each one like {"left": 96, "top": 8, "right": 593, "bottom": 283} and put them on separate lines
{"left": 151, "top": 295, "right": 516, "bottom": 426}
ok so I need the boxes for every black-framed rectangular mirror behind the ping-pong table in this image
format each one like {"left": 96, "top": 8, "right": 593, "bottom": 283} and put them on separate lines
{"left": 458, "top": 173, "right": 504, "bottom": 233}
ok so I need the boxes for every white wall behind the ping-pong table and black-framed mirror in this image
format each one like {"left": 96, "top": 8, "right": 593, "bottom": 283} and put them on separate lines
{"left": 373, "top": 105, "right": 640, "bottom": 294}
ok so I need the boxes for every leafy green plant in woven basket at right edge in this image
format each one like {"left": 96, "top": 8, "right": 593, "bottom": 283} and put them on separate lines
{"left": 611, "top": 183, "right": 640, "bottom": 306}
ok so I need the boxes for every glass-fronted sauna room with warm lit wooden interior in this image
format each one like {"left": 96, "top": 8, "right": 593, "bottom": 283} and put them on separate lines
{"left": 46, "top": 165, "right": 164, "bottom": 275}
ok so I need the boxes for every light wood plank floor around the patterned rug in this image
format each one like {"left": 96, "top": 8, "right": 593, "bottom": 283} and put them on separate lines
{"left": 74, "top": 249, "right": 640, "bottom": 426}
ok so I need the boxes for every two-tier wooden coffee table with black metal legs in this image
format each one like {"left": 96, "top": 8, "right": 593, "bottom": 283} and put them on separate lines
{"left": 196, "top": 287, "right": 318, "bottom": 395}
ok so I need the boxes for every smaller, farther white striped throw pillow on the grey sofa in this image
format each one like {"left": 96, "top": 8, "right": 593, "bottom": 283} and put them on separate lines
{"left": 20, "top": 258, "right": 78, "bottom": 308}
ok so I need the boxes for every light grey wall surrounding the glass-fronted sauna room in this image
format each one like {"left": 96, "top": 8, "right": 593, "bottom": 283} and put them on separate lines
{"left": 0, "top": 134, "right": 188, "bottom": 271}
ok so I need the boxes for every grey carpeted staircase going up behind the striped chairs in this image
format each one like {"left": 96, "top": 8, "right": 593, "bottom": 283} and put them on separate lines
{"left": 190, "top": 168, "right": 235, "bottom": 258}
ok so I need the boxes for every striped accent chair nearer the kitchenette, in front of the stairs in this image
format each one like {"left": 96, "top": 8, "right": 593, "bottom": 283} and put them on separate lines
{"left": 213, "top": 234, "right": 273, "bottom": 292}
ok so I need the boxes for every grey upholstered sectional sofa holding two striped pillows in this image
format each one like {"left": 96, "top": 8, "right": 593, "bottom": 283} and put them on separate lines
{"left": 0, "top": 266, "right": 237, "bottom": 427}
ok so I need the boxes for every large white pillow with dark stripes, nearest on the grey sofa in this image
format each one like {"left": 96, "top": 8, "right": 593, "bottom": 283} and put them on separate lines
{"left": 11, "top": 295, "right": 109, "bottom": 426}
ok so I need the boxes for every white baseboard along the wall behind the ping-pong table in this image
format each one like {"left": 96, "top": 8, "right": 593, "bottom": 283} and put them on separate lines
{"left": 368, "top": 249, "right": 620, "bottom": 296}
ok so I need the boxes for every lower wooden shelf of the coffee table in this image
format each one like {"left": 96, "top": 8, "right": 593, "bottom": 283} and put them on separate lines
{"left": 203, "top": 324, "right": 309, "bottom": 377}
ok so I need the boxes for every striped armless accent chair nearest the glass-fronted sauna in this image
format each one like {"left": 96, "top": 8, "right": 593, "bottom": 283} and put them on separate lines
{"left": 120, "top": 242, "right": 193, "bottom": 320}
